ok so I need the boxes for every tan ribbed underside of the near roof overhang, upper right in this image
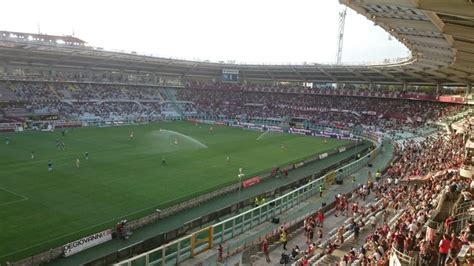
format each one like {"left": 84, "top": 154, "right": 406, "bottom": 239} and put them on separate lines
{"left": 340, "top": 0, "right": 474, "bottom": 83}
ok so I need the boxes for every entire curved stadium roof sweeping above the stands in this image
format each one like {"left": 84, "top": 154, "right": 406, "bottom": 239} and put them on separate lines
{"left": 0, "top": 0, "right": 474, "bottom": 84}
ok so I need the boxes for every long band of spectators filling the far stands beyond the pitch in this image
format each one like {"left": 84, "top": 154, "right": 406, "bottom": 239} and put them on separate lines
{"left": 0, "top": 81, "right": 462, "bottom": 130}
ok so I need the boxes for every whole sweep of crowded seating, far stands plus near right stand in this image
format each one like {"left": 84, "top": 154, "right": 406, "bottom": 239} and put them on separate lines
{"left": 0, "top": 74, "right": 471, "bottom": 265}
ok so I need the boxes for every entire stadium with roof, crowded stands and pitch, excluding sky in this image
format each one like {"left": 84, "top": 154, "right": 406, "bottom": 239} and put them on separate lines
{"left": 0, "top": 0, "right": 474, "bottom": 266}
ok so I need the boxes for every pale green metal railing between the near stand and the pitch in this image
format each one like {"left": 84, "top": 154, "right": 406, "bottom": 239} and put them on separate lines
{"left": 115, "top": 130, "right": 381, "bottom": 266}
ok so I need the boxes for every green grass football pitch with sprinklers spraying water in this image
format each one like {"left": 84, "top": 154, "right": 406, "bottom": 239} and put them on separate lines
{"left": 0, "top": 122, "right": 348, "bottom": 263}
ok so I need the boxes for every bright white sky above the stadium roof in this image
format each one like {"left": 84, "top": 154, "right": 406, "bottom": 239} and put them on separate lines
{"left": 0, "top": 0, "right": 409, "bottom": 63}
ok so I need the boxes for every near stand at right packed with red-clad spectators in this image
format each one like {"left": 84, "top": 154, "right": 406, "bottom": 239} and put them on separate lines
{"left": 197, "top": 116, "right": 474, "bottom": 265}
